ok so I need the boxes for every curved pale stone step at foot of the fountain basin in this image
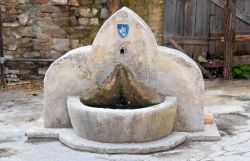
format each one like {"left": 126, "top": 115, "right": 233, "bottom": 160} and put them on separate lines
{"left": 59, "top": 130, "right": 186, "bottom": 154}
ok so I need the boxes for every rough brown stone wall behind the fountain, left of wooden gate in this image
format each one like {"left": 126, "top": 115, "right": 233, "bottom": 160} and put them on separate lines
{"left": 1, "top": 0, "right": 163, "bottom": 81}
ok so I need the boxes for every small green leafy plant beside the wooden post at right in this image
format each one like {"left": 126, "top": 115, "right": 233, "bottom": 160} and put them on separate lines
{"left": 233, "top": 64, "right": 250, "bottom": 79}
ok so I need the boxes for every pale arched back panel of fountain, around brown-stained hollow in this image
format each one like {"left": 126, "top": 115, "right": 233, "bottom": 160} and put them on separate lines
{"left": 44, "top": 8, "right": 204, "bottom": 132}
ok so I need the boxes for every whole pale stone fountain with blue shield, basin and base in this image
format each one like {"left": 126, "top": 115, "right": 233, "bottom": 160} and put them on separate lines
{"left": 26, "top": 7, "right": 220, "bottom": 153}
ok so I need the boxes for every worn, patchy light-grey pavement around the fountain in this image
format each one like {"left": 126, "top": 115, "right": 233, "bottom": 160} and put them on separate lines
{"left": 0, "top": 80, "right": 250, "bottom": 161}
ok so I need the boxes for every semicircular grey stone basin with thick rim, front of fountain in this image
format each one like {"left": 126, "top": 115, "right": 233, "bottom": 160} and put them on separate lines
{"left": 67, "top": 96, "right": 177, "bottom": 143}
